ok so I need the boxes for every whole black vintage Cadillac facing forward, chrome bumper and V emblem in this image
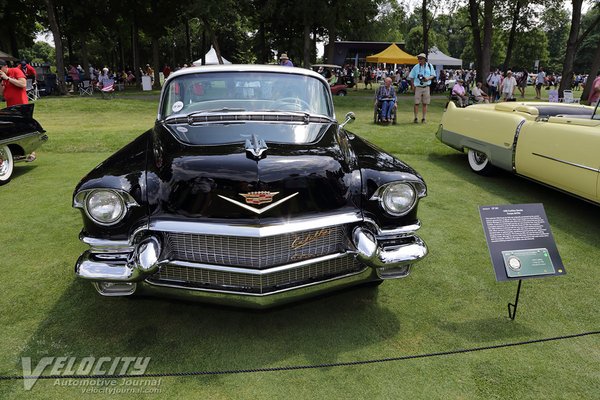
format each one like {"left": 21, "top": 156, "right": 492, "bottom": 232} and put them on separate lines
{"left": 73, "top": 65, "right": 427, "bottom": 307}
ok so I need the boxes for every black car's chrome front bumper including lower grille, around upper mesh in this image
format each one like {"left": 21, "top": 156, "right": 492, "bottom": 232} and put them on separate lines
{"left": 75, "top": 215, "right": 427, "bottom": 307}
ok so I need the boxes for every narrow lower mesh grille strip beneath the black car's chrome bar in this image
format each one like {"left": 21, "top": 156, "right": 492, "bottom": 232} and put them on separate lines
{"left": 147, "top": 255, "right": 366, "bottom": 294}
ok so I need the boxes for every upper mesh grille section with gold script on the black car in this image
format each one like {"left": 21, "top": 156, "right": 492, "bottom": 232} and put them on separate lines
{"left": 166, "top": 225, "right": 352, "bottom": 269}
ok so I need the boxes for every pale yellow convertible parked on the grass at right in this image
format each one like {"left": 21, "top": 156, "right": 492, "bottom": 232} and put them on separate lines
{"left": 436, "top": 102, "right": 600, "bottom": 204}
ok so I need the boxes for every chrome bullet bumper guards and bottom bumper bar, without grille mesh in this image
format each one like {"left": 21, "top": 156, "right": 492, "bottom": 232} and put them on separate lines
{"left": 75, "top": 216, "right": 427, "bottom": 298}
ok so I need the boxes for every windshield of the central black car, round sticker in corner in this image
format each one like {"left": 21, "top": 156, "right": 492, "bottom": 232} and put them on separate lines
{"left": 161, "top": 71, "right": 333, "bottom": 118}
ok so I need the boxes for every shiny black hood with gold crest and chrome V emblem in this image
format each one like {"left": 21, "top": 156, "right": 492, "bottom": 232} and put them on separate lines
{"left": 147, "top": 123, "right": 360, "bottom": 220}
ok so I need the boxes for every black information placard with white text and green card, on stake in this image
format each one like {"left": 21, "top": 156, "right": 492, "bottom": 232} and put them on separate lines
{"left": 479, "top": 203, "right": 566, "bottom": 281}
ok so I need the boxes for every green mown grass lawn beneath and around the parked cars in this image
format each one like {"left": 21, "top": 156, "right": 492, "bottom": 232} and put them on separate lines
{"left": 0, "top": 88, "right": 600, "bottom": 399}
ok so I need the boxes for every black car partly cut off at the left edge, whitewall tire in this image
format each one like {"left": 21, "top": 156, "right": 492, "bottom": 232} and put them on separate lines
{"left": 0, "top": 104, "right": 48, "bottom": 185}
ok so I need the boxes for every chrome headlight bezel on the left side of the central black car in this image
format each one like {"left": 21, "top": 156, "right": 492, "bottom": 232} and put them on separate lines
{"left": 73, "top": 188, "right": 138, "bottom": 226}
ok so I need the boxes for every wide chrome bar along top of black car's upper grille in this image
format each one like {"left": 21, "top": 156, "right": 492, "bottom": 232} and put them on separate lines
{"left": 146, "top": 212, "right": 363, "bottom": 237}
